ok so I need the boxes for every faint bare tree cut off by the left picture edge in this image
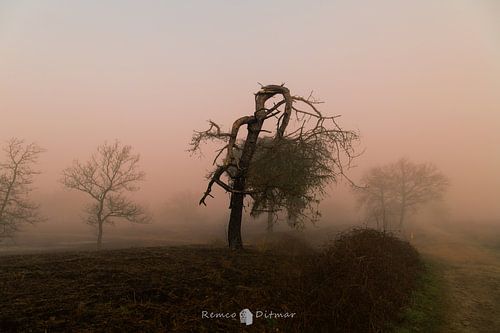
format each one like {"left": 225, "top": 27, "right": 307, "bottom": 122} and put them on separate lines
{"left": 0, "top": 138, "right": 44, "bottom": 241}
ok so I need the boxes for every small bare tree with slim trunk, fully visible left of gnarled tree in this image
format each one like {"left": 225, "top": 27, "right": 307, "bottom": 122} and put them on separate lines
{"left": 61, "top": 141, "right": 150, "bottom": 248}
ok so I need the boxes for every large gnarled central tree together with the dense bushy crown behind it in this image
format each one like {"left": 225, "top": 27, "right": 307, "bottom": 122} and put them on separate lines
{"left": 190, "top": 85, "right": 358, "bottom": 249}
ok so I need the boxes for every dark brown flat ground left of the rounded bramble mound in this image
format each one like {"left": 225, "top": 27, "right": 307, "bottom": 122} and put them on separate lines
{"left": 0, "top": 247, "right": 306, "bottom": 332}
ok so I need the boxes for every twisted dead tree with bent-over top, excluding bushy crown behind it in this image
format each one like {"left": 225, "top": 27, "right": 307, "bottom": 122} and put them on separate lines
{"left": 190, "top": 85, "right": 358, "bottom": 249}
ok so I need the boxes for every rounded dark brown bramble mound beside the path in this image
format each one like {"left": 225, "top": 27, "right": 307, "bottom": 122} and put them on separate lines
{"left": 304, "top": 229, "right": 423, "bottom": 332}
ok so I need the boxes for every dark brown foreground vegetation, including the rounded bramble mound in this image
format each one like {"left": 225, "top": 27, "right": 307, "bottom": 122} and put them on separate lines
{"left": 0, "top": 229, "right": 420, "bottom": 332}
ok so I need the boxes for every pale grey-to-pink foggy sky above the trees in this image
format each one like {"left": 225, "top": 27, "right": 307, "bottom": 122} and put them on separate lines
{"left": 0, "top": 0, "right": 500, "bottom": 231}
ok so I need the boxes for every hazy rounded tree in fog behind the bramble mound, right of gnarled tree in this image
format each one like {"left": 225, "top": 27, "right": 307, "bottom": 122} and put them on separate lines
{"left": 354, "top": 158, "right": 449, "bottom": 230}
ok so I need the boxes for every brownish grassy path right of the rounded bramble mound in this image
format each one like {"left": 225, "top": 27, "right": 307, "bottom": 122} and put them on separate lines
{"left": 416, "top": 231, "right": 500, "bottom": 333}
